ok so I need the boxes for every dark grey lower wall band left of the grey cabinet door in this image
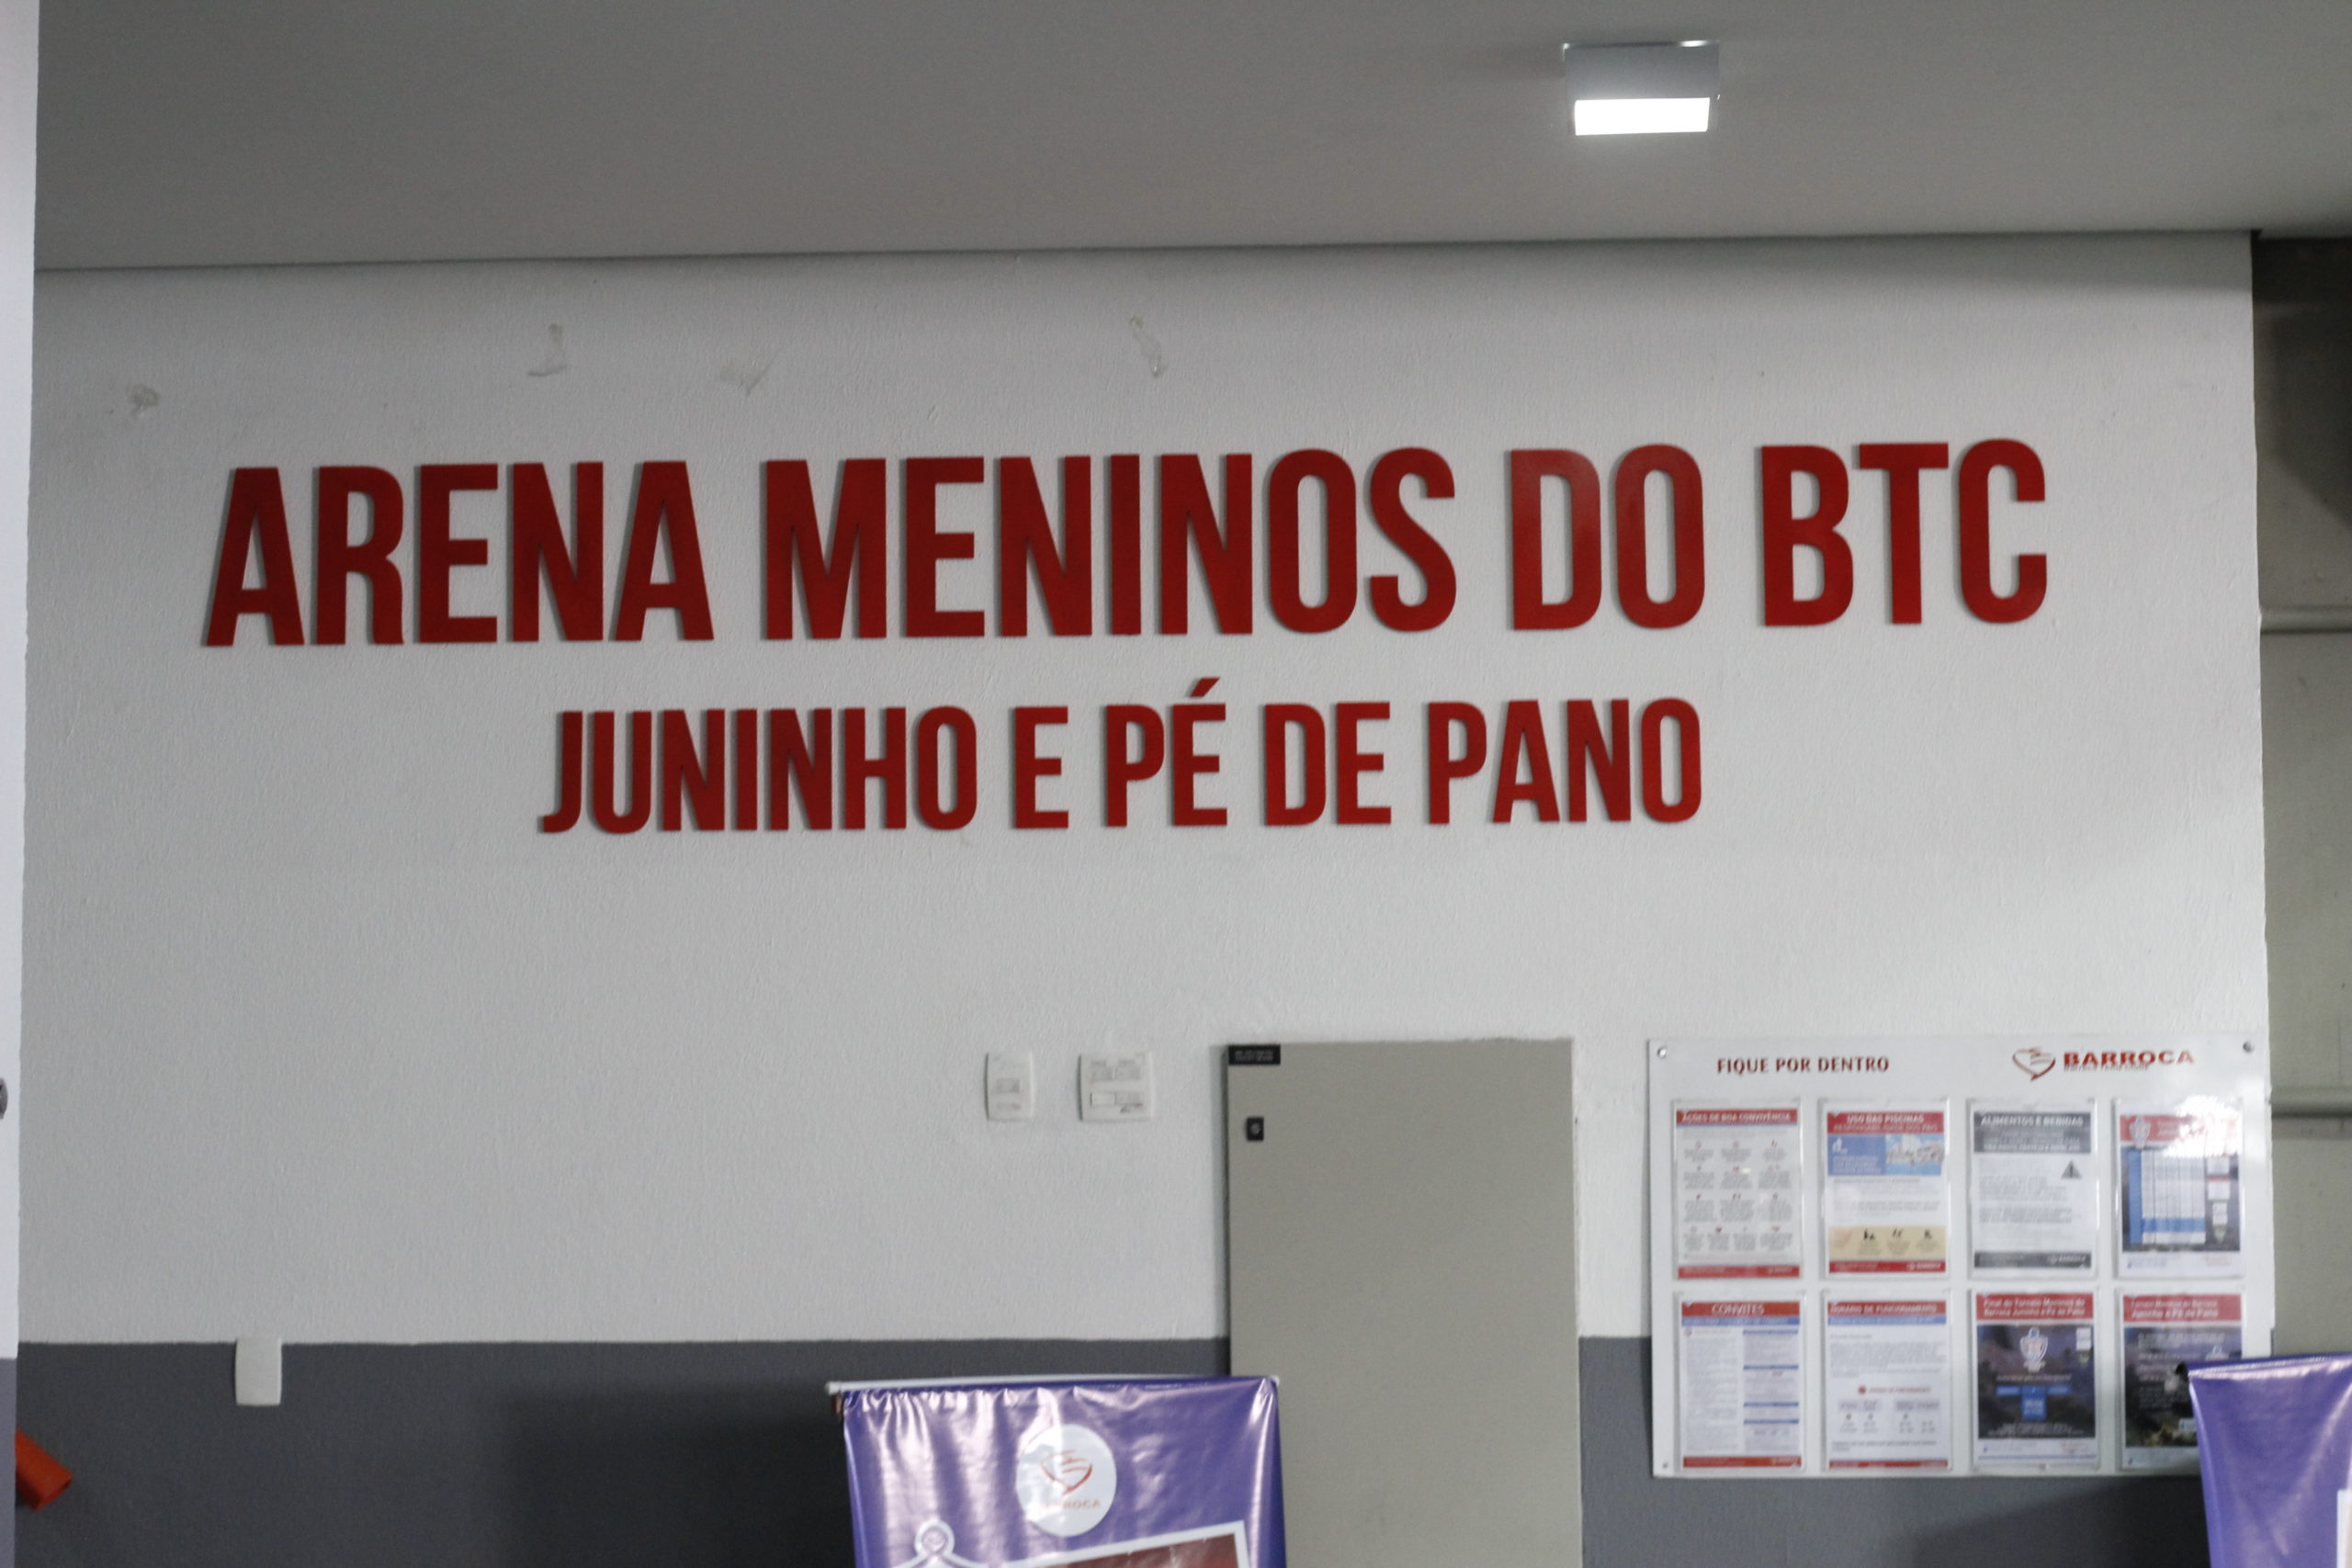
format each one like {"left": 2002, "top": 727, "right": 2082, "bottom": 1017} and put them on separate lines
{"left": 17, "top": 1340, "right": 1223, "bottom": 1568}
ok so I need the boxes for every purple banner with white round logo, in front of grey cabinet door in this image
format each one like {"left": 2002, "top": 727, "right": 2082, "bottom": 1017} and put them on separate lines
{"left": 842, "top": 1378, "right": 1284, "bottom": 1568}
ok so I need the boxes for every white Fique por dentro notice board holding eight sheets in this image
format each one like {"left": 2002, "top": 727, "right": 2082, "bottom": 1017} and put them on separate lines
{"left": 1649, "top": 1034, "right": 2275, "bottom": 1479}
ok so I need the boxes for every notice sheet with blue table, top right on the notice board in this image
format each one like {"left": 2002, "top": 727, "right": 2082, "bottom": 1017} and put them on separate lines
{"left": 2114, "top": 1096, "right": 2246, "bottom": 1277}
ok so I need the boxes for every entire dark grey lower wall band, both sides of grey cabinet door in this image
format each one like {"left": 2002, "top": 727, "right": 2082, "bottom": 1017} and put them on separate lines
{"left": 17, "top": 1340, "right": 2206, "bottom": 1568}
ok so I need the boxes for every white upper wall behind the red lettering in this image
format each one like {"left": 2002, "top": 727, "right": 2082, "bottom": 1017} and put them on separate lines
{"left": 26, "top": 237, "right": 2265, "bottom": 1340}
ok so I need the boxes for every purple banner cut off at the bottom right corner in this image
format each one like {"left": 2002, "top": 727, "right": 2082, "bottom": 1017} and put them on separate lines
{"left": 2189, "top": 1357, "right": 2352, "bottom": 1568}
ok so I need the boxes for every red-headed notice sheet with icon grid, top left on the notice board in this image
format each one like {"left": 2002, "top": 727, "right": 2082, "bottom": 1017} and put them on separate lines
{"left": 1675, "top": 1102, "right": 1804, "bottom": 1279}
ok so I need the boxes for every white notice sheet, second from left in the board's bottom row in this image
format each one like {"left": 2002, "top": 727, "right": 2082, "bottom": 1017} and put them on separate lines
{"left": 1820, "top": 1295, "right": 1952, "bottom": 1470}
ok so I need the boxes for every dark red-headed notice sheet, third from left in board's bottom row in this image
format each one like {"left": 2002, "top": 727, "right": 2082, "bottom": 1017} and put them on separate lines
{"left": 1975, "top": 1291, "right": 2098, "bottom": 1470}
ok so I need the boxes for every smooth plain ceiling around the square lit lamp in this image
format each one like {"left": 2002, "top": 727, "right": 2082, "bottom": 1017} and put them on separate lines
{"left": 40, "top": 0, "right": 2352, "bottom": 268}
